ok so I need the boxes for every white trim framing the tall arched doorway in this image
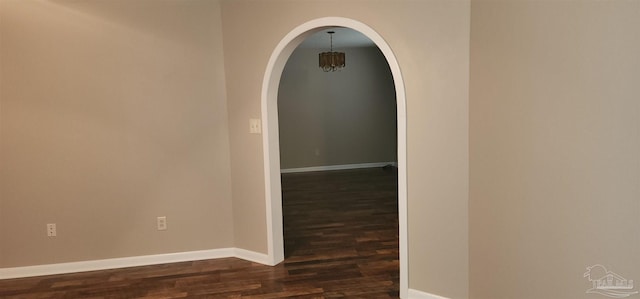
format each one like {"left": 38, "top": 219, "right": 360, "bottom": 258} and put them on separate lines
{"left": 261, "top": 17, "right": 409, "bottom": 298}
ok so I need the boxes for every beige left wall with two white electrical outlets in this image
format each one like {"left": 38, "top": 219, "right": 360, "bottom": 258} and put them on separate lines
{"left": 0, "top": 0, "right": 233, "bottom": 268}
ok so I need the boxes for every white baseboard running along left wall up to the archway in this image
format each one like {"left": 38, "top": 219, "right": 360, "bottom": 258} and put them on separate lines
{"left": 0, "top": 248, "right": 269, "bottom": 279}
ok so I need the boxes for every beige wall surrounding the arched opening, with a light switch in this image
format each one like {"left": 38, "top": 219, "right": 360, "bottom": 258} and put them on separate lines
{"left": 222, "top": 0, "right": 470, "bottom": 298}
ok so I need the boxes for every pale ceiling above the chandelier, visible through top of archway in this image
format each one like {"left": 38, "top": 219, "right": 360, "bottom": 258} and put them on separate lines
{"left": 300, "top": 27, "right": 375, "bottom": 49}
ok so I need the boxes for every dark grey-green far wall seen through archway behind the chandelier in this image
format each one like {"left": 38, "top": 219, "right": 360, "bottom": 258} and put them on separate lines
{"left": 278, "top": 46, "right": 397, "bottom": 169}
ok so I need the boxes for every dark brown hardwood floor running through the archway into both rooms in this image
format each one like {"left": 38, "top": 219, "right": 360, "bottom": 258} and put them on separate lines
{"left": 0, "top": 168, "right": 399, "bottom": 299}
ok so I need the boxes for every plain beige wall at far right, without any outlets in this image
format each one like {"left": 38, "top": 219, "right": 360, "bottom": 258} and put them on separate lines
{"left": 469, "top": 0, "right": 640, "bottom": 299}
